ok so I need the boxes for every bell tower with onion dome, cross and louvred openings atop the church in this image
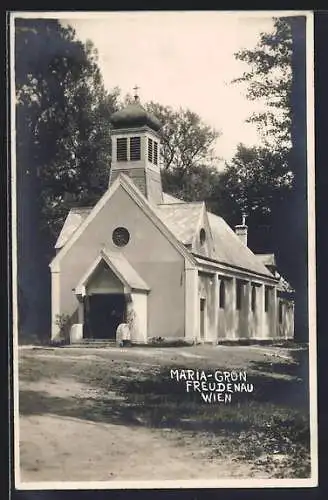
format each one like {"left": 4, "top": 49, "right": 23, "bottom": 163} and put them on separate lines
{"left": 109, "top": 87, "right": 163, "bottom": 204}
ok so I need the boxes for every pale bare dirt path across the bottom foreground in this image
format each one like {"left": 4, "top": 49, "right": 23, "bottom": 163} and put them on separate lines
{"left": 20, "top": 379, "right": 268, "bottom": 482}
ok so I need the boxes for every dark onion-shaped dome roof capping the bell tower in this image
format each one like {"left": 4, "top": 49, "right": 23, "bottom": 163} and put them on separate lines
{"left": 110, "top": 96, "right": 162, "bottom": 132}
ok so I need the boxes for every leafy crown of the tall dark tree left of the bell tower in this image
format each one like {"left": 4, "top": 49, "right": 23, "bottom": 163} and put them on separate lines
{"left": 15, "top": 19, "right": 118, "bottom": 235}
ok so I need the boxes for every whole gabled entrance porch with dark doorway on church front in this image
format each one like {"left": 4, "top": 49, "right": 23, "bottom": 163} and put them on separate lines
{"left": 70, "top": 249, "right": 150, "bottom": 343}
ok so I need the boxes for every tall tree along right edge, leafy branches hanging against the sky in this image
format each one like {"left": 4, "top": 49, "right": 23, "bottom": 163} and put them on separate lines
{"left": 231, "top": 16, "right": 310, "bottom": 339}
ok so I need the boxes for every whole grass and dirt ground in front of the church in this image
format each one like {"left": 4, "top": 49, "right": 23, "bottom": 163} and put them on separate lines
{"left": 19, "top": 346, "right": 310, "bottom": 481}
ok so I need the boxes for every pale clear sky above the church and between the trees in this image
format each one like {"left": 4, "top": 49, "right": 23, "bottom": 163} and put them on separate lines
{"left": 61, "top": 11, "right": 276, "bottom": 166}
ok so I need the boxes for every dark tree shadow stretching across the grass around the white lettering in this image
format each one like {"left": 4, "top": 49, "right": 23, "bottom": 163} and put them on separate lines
{"left": 20, "top": 355, "right": 309, "bottom": 451}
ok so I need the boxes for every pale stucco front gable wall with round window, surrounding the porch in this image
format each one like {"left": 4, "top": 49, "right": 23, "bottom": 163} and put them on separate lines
{"left": 53, "top": 187, "right": 185, "bottom": 338}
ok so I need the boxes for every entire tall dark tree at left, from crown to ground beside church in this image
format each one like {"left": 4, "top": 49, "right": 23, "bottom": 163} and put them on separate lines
{"left": 15, "top": 18, "right": 118, "bottom": 338}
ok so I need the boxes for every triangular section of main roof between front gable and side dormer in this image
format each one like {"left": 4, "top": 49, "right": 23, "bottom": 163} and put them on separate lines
{"left": 155, "top": 202, "right": 203, "bottom": 245}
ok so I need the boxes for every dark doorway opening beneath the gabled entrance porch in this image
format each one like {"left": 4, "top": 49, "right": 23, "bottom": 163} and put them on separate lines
{"left": 83, "top": 293, "right": 126, "bottom": 339}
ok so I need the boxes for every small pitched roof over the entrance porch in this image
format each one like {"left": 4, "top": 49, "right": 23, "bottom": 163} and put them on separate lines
{"left": 75, "top": 248, "right": 150, "bottom": 294}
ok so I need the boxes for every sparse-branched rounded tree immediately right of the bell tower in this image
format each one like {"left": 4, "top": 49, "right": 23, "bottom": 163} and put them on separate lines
{"left": 145, "top": 102, "right": 220, "bottom": 172}
